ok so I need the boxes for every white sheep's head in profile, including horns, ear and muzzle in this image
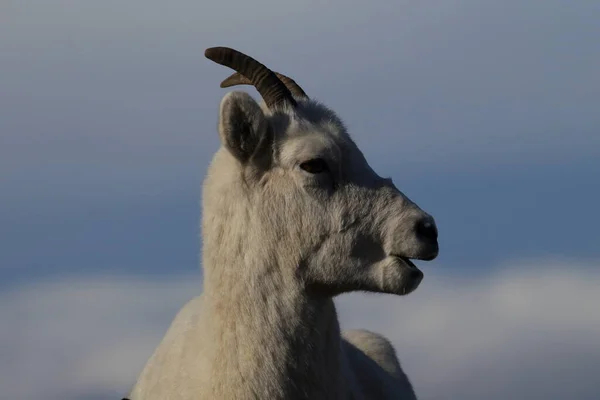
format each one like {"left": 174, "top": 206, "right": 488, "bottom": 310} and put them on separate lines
{"left": 203, "top": 47, "right": 438, "bottom": 296}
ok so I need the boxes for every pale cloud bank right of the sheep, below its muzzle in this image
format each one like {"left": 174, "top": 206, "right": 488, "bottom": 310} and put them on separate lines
{"left": 340, "top": 262, "right": 600, "bottom": 400}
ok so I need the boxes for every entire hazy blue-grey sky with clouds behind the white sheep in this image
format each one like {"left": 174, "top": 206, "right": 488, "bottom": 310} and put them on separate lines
{"left": 0, "top": 0, "right": 600, "bottom": 400}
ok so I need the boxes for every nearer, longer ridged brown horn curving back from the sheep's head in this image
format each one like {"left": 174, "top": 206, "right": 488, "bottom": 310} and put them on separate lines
{"left": 204, "top": 47, "right": 296, "bottom": 109}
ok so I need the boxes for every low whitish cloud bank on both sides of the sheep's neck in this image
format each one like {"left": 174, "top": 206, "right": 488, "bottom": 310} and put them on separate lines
{"left": 0, "top": 262, "right": 600, "bottom": 400}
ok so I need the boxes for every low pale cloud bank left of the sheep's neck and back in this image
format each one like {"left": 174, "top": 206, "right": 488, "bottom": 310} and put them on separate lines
{"left": 0, "top": 276, "right": 201, "bottom": 400}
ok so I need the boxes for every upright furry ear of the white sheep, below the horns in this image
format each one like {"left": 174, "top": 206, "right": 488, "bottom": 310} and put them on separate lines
{"left": 219, "top": 92, "right": 273, "bottom": 168}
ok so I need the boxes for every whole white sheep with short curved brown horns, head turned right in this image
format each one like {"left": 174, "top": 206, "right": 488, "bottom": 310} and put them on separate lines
{"left": 124, "top": 47, "right": 438, "bottom": 400}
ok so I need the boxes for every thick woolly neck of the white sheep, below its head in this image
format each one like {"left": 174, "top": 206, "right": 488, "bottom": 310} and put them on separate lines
{"left": 205, "top": 257, "right": 343, "bottom": 399}
